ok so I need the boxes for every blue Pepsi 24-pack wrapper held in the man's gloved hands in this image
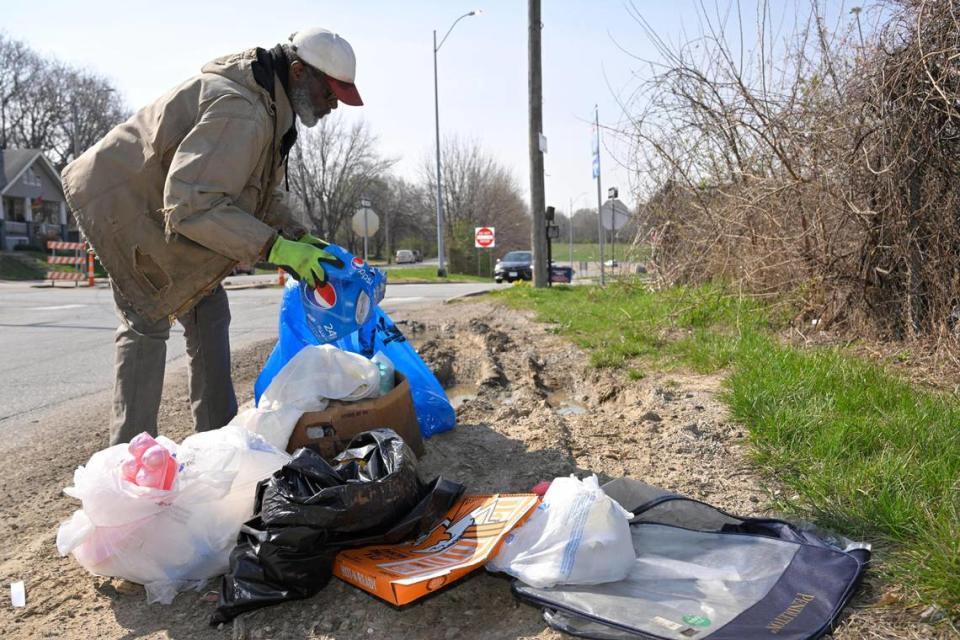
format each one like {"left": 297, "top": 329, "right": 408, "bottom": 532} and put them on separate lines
{"left": 299, "top": 244, "right": 386, "bottom": 344}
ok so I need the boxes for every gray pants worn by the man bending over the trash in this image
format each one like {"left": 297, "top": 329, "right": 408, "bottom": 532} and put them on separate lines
{"left": 110, "top": 286, "right": 237, "bottom": 445}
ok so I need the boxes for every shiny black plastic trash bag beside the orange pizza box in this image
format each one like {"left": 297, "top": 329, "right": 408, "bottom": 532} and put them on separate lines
{"left": 210, "top": 429, "right": 464, "bottom": 626}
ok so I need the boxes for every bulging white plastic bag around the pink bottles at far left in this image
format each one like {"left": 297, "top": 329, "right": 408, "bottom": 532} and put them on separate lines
{"left": 57, "top": 426, "right": 290, "bottom": 604}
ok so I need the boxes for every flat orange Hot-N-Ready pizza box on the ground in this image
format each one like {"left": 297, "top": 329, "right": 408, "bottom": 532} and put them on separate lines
{"left": 333, "top": 493, "right": 537, "bottom": 606}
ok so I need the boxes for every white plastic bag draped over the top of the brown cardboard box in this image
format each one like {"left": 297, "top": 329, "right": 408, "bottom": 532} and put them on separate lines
{"left": 242, "top": 345, "right": 380, "bottom": 449}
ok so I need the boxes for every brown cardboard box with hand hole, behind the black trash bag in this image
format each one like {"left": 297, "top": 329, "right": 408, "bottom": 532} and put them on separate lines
{"left": 287, "top": 372, "right": 424, "bottom": 459}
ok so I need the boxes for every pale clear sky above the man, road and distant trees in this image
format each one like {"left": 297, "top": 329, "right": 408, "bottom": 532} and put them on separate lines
{"left": 0, "top": 0, "right": 856, "bottom": 215}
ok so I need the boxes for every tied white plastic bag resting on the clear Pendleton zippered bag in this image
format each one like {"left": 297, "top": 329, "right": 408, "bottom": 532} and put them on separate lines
{"left": 487, "top": 475, "right": 636, "bottom": 588}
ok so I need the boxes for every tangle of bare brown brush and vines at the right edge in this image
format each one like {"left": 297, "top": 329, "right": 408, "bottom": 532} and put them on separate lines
{"left": 621, "top": 0, "right": 960, "bottom": 340}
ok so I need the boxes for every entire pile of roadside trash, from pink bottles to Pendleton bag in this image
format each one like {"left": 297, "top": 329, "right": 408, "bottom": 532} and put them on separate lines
{"left": 57, "top": 246, "right": 870, "bottom": 640}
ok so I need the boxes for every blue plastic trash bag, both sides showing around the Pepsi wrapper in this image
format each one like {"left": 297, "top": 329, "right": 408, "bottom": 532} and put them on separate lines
{"left": 253, "top": 251, "right": 456, "bottom": 438}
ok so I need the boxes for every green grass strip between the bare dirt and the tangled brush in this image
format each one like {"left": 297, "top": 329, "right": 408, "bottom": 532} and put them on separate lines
{"left": 496, "top": 284, "right": 960, "bottom": 616}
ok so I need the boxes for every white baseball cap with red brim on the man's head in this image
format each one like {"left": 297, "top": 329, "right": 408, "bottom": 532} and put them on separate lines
{"left": 290, "top": 27, "right": 363, "bottom": 107}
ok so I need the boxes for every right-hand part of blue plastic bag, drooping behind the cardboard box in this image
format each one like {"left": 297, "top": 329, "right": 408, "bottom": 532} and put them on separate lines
{"left": 335, "top": 307, "right": 457, "bottom": 438}
